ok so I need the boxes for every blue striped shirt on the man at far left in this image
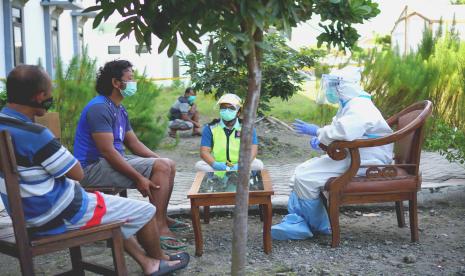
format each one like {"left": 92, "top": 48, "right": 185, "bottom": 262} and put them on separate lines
{"left": 0, "top": 107, "right": 88, "bottom": 235}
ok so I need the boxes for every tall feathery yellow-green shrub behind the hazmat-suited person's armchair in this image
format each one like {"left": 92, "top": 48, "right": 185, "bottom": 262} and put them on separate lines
{"left": 364, "top": 23, "right": 465, "bottom": 163}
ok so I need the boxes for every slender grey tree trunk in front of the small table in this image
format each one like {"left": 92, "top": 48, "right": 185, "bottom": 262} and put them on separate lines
{"left": 231, "top": 30, "right": 263, "bottom": 276}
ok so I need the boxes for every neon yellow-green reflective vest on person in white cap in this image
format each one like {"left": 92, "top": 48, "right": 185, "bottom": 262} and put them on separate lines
{"left": 210, "top": 123, "right": 241, "bottom": 164}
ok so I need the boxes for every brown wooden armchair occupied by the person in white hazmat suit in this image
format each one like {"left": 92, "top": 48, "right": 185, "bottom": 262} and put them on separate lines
{"left": 322, "top": 101, "right": 432, "bottom": 247}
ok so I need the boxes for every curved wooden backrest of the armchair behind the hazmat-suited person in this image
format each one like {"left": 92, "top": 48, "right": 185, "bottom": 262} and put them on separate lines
{"left": 388, "top": 101, "right": 432, "bottom": 175}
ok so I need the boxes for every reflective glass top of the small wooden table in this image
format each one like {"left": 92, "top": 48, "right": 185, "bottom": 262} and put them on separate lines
{"left": 199, "top": 171, "right": 263, "bottom": 193}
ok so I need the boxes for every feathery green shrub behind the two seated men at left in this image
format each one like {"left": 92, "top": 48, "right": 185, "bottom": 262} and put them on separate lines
{"left": 52, "top": 52, "right": 166, "bottom": 150}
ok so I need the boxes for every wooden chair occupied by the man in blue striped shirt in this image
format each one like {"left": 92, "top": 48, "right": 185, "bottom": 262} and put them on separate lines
{"left": 0, "top": 131, "right": 127, "bottom": 275}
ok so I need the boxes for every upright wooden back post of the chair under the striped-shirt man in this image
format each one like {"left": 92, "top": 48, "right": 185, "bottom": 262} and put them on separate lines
{"left": 0, "top": 130, "right": 29, "bottom": 246}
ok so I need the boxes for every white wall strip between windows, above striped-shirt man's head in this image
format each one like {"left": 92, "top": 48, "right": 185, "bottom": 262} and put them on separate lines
{"left": 23, "top": 0, "right": 45, "bottom": 67}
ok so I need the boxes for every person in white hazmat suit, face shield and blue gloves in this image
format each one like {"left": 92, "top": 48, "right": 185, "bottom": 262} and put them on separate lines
{"left": 271, "top": 67, "right": 393, "bottom": 240}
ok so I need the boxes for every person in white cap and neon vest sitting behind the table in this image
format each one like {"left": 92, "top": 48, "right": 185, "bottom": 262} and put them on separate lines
{"left": 195, "top": 94, "right": 263, "bottom": 172}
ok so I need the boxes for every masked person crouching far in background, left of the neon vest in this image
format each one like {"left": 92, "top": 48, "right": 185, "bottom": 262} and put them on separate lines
{"left": 168, "top": 87, "right": 201, "bottom": 138}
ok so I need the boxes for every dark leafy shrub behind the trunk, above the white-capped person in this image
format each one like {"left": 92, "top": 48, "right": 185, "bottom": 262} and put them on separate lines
{"left": 180, "top": 34, "right": 325, "bottom": 113}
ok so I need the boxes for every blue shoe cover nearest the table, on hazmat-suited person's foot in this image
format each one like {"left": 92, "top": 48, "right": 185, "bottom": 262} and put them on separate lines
{"left": 271, "top": 214, "right": 313, "bottom": 240}
